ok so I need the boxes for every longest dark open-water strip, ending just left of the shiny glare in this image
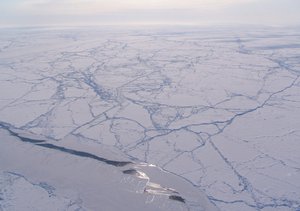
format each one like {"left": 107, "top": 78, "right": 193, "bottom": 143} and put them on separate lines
{"left": 36, "top": 143, "right": 132, "bottom": 167}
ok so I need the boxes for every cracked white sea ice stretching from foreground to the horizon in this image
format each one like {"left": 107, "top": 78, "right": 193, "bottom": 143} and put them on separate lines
{"left": 0, "top": 26, "right": 300, "bottom": 211}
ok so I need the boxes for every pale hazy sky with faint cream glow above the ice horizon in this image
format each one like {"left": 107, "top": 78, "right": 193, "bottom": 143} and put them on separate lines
{"left": 0, "top": 0, "right": 300, "bottom": 26}
